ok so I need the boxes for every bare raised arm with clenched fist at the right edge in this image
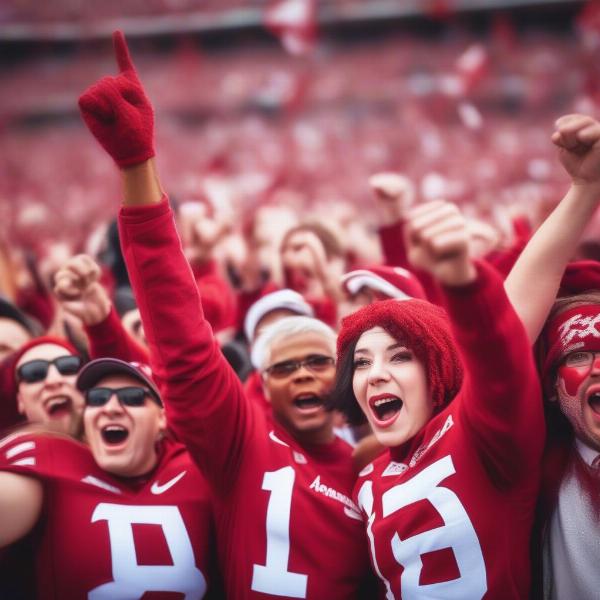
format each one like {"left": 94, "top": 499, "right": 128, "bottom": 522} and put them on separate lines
{"left": 505, "top": 115, "right": 600, "bottom": 344}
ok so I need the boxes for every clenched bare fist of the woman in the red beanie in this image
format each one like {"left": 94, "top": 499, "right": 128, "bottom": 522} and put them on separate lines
{"left": 404, "top": 200, "right": 476, "bottom": 285}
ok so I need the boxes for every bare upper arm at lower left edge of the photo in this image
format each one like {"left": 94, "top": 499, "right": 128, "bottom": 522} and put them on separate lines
{"left": 0, "top": 472, "right": 44, "bottom": 548}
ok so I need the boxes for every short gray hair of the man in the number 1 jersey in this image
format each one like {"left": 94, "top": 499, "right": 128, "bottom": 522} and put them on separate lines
{"left": 250, "top": 316, "right": 337, "bottom": 371}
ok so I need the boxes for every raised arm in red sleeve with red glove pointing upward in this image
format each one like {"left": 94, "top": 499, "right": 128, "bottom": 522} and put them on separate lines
{"left": 80, "top": 32, "right": 258, "bottom": 490}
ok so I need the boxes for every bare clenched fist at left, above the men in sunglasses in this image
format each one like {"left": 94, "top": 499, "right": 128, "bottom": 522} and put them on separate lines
{"left": 54, "top": 254, "right": 111, "bottom": 326}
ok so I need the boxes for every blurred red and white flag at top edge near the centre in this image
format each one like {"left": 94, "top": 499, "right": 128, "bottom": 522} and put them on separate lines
{"left": 264, "top": 0, "right": 317, "bottom": 55}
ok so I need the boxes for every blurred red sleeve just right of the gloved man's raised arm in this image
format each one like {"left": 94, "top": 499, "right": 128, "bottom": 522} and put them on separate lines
{"left": 193, "top": 260, "right": 236, "bottom": 331}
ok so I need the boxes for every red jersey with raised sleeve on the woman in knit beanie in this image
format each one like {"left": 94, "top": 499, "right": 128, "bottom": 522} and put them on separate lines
{"left": 355, "top": 267, "right": 544, "bottom": 600}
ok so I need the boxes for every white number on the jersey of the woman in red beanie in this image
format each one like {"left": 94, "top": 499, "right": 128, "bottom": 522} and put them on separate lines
{"left": 359, "top": 456, "right": 487, "bottom": 600}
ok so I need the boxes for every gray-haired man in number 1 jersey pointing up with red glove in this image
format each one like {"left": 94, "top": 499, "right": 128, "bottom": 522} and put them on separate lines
{"left": 79, "top": 32, "right": 368, "bottom": 599}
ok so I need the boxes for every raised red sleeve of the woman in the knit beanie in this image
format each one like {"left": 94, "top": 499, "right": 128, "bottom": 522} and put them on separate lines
{"left": 444, "top": 262, "right": 545, "bottom": 482}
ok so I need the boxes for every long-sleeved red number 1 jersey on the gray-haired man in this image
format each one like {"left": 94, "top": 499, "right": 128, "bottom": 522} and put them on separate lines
{"left": 119, "top": 201, "right": 369, "bottom": 600}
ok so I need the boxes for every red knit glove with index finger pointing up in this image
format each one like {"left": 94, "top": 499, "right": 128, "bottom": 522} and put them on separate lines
{"left": 79, "top": 31, "right": 155, "bottom": 168}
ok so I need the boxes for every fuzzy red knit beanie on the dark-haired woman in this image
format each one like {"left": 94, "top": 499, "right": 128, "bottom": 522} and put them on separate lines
{"left": 337, "top": 299, "right": 463, "bottom": 409}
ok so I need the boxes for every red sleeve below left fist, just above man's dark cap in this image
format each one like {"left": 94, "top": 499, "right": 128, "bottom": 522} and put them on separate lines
{"left": 85, "top": 306, "right": 149, "bottom": 363}
